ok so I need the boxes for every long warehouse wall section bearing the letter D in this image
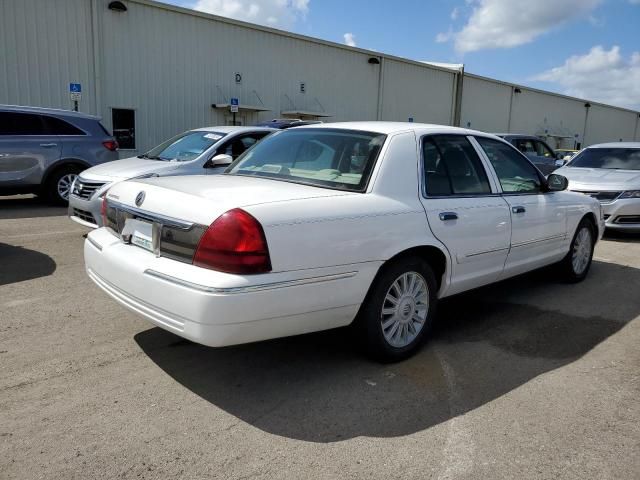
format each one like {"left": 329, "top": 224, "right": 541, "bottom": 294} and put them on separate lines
{"left": 102, "top": 2, "right": 380, "bottom": 152}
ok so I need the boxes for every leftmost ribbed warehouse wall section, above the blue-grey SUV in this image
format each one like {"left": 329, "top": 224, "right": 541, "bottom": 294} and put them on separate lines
{"left": 0, "top": 0, "right": 96, "bottom": 113}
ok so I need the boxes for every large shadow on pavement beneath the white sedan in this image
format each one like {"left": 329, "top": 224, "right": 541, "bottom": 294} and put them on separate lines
{"left": 135, "top": 262, "right": 640, "bottom": 442}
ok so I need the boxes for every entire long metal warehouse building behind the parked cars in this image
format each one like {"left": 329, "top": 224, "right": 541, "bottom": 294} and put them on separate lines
{"left": 0, "top": 0, "right": 640, "bottom": 156}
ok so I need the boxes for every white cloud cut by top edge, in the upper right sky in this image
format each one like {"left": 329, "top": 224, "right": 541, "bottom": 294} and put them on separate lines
{"left": 452, "top": 0, "right": 602, "bottom": 53}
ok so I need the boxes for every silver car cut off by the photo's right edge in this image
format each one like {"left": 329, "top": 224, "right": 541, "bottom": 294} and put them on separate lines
{"left": 556, "top": 142, "right": 640, "bottom": 231}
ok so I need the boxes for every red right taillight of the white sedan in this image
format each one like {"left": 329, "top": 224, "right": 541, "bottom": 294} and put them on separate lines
{"left": 193, "top": 208, "right": 271, "bottom": 273}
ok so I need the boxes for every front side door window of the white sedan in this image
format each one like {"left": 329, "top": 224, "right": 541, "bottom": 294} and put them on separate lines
{"left": 476, "top": 137, "right": 542, "bottom": 193}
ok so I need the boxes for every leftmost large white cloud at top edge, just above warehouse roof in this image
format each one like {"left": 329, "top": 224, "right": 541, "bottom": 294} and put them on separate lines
{"left": 193, "top": 0, "right": 310, "bottom": 28}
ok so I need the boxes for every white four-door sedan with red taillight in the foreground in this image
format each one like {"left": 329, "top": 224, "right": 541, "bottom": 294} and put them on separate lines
{"left": 84, "top": 122, "right": 604, "bottom": 360}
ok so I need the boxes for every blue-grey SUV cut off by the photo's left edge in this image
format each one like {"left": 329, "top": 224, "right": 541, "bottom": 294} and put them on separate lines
{"left": 0, "top": 105, "right": 118, "bottom": 204}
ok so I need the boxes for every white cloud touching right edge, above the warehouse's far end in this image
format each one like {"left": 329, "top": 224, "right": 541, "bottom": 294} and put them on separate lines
{"left": 533, "top": 45, "right": 640, "bottom": 109}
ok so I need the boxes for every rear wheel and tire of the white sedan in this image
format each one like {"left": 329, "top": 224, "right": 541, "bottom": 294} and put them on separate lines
{"left": 354, "top": 257, "right": 438, "bottom": 362}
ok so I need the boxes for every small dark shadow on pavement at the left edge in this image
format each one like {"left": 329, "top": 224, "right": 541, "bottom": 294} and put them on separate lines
{"left": 0, "top": 242, "right": 56, "bottom": 285}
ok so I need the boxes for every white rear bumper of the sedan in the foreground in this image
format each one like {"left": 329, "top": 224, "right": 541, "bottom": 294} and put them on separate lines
{"left": 84, "top": 228, "right": 379, "bottom": 347}
